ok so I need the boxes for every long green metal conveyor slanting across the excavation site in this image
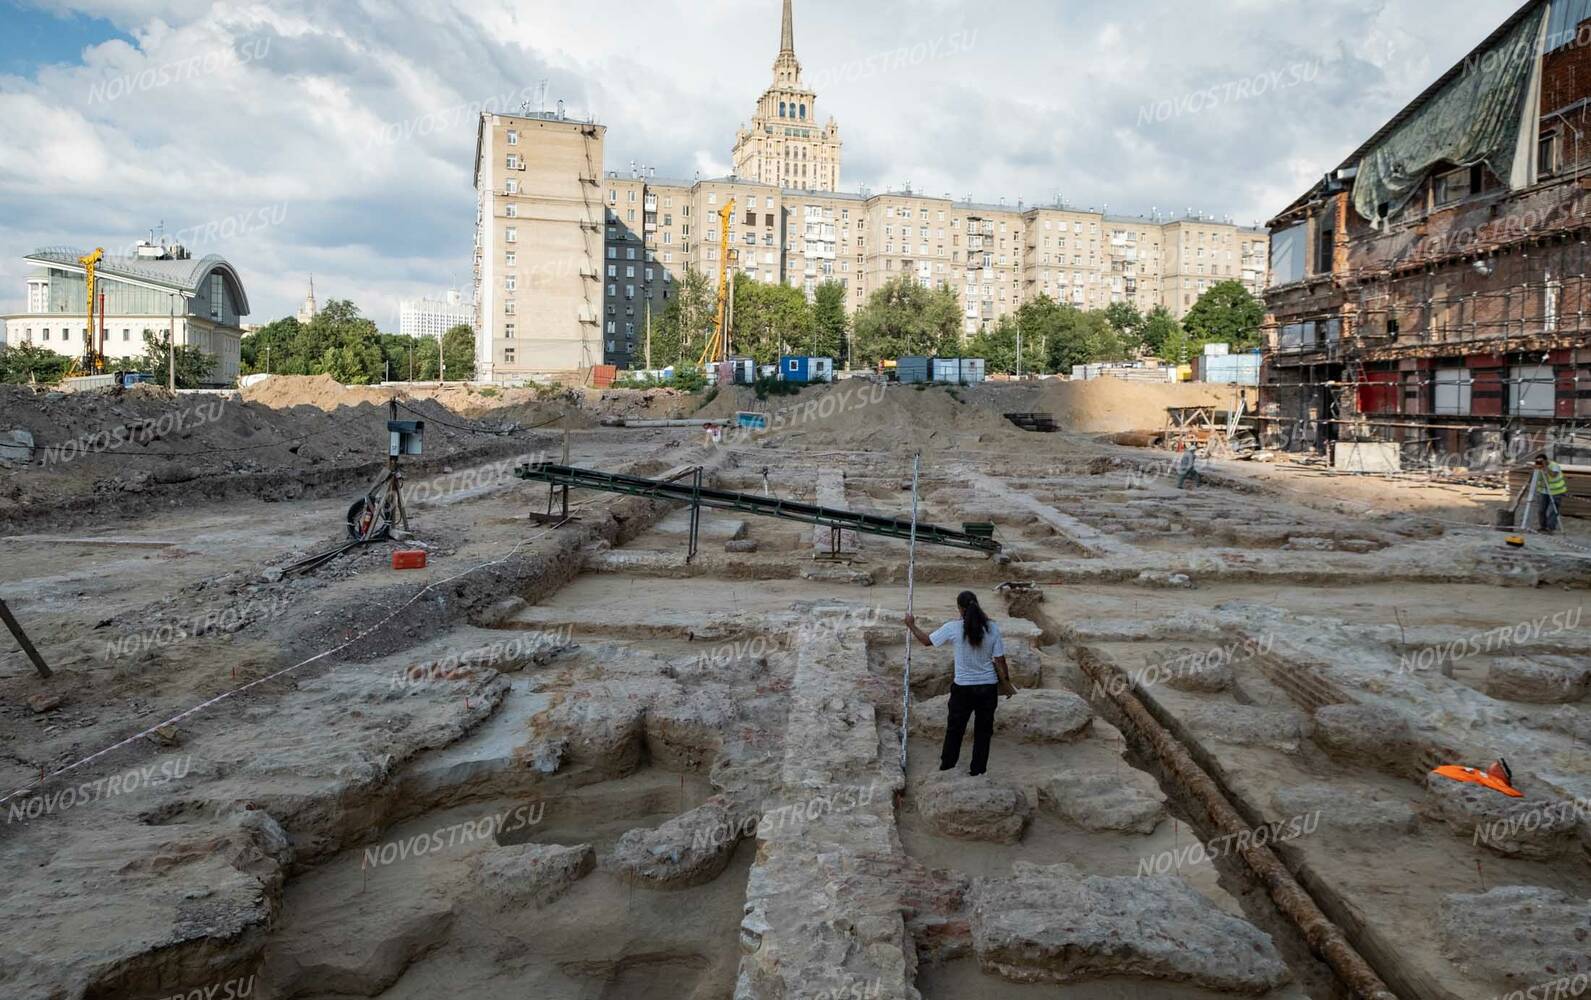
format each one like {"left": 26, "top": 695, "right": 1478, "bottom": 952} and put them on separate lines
{"left": 514, "top": 463, "right": 1001, "bottom": 555}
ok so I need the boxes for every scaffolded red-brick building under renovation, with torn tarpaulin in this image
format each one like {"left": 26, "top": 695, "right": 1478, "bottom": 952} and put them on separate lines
{"left": 1260, "top": 0, "right": 1591, "bottom": 469}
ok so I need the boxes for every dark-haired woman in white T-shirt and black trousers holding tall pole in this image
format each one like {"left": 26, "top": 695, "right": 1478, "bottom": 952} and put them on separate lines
{"left": 905, "top": 590, "right": 1017, "bottom": 776}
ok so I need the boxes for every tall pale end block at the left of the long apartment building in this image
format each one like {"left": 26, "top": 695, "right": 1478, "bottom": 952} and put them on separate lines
{"left": 474, "top": 111, "right": 606, "bottom": 382}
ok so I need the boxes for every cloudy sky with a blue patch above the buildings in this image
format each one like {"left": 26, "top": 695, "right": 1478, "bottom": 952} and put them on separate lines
{"left": 0, "top": 0, "right": 1519, "bottom": 329}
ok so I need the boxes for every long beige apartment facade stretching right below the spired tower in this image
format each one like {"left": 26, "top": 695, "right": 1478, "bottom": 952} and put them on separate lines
{"left": 582, "top": 172, "right": 1266, "bottom": 367}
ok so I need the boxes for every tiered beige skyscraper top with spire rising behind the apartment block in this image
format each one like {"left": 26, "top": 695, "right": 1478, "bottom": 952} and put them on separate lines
{"left": 733, "top": 0, "right": 840, "bottom": 191}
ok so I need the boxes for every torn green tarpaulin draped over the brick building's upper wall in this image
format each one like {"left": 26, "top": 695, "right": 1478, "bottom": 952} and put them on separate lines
{"left": 1354, "top": 3, "right": 1548, "bottom": 223}
